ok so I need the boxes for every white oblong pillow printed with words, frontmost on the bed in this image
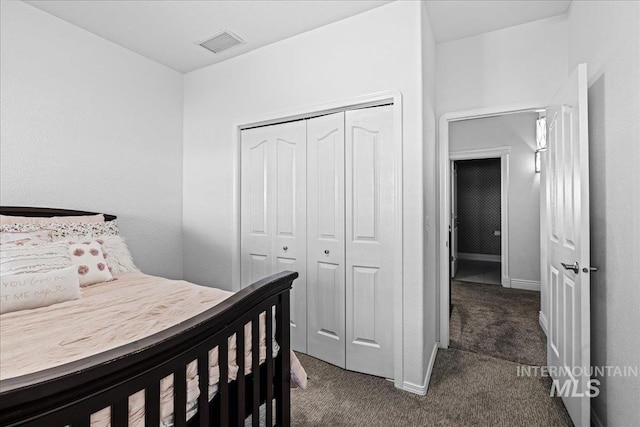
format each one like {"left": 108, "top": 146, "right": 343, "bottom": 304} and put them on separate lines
{"left": 0, "top": 267, "right": 80, "bottom": 314}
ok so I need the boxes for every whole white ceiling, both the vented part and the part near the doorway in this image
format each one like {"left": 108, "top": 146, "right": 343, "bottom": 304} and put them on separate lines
{"left": 24, "top": 0, "right": 571, "bottom": 73}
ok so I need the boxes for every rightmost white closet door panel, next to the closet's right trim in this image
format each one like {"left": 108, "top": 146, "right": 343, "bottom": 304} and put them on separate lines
{"left": 345, "top": 105, "right": 400, "bottom": 378}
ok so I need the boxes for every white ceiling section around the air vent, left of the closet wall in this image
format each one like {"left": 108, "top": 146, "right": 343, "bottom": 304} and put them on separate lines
{"left": 25, "top": 0, "right": 390, "bottom": 73}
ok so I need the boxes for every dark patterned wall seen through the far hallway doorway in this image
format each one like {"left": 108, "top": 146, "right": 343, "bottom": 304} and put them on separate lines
{"left": 456, "top": 159, "right": 500, "bottom": 255}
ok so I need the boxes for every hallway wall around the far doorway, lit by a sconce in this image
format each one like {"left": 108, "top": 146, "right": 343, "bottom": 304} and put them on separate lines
{"left": 449, "top": 112, "right": 540, "bottom": 284}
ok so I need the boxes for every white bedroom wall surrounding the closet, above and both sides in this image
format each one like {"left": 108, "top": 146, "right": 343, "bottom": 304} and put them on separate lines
{"left": 183, "top": 2, "right": 425, "bottom": 385}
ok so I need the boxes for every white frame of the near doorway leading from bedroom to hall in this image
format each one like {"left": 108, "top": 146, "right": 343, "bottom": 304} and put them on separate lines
{"left": 436, "top": 104, "right": 545, "bottom": 348}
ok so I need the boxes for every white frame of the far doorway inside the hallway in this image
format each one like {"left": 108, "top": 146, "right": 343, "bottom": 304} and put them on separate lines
{"left": 447, "top": 147, "right": 511, "bottom": 292}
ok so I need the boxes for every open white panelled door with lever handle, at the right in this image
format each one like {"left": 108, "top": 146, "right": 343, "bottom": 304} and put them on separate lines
{"left": 545, "top": 64, "right": 595, "bottom": 426}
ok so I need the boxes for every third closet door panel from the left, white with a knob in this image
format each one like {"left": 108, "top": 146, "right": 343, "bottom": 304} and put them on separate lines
{"left": 307, "top": 113, "right": 345, "bottom": 368}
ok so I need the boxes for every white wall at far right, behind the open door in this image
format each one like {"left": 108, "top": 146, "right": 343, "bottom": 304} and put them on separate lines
{"left": 569, "top": 1, "right": 640, "bottom": 426}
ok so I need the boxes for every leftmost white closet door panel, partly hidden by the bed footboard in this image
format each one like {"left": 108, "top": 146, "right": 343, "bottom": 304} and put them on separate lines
{"left": 240, "top": 129, "right": 272, "bottom": 287}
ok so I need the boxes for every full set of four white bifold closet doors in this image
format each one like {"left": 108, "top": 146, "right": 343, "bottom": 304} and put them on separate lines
{"left": 240, "top": 105, "right": 401, "bottom": 378}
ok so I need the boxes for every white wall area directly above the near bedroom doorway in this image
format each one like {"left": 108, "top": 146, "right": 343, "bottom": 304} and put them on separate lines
{"left": 436, "top": 16, "right": 567, "bottom": 117}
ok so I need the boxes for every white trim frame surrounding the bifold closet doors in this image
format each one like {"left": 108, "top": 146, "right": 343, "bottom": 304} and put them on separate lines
{"left": 231, "top": 90, "right": 404, "bottom": 388}
